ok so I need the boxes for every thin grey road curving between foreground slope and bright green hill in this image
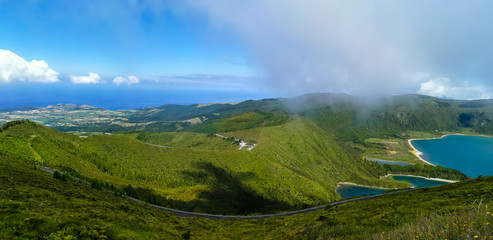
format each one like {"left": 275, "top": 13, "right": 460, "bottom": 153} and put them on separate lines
{"left": 40, "top": 166, "right": 422, "bottom": 220}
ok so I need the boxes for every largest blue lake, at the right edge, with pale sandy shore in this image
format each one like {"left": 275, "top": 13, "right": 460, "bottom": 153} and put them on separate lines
{"left": 411, "top": 135, "right": 493, "bottom": 178}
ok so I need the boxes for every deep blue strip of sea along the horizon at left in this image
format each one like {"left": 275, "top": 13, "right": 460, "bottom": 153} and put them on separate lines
{"left": 0, "top": 83, "right": 268, "bottom": 110}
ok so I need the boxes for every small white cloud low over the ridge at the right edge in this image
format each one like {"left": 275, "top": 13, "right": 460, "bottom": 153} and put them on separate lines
{"left": 418, "top": 77, "right": 493, "bottom": 100}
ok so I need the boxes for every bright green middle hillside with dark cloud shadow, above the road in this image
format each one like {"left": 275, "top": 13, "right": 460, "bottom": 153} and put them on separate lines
{"left": 0, "top": 118, "right": 406, "bottom": 213}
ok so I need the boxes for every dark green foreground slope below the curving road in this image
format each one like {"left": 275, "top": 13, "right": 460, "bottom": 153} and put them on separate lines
{"left": 0, "top": 155, "right": 493, "bottom": 239}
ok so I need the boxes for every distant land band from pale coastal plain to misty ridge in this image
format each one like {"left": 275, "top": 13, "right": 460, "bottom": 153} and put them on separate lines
{"left": 0, "top": 93, "right": 493, "bottom": 141}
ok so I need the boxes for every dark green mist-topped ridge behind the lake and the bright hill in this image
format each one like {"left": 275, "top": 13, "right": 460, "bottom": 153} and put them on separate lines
{"left": 124, "top": 93, "right": 493, "bottom": 137}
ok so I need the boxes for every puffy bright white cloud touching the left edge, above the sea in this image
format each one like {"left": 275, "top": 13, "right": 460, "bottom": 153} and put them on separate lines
{"left": 0, "top": 49, "right": 59, "bottom": 82}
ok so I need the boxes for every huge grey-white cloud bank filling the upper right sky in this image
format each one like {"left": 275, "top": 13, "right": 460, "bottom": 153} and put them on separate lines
{"left": 185, "top": 0, "right": 493, "bottom": 98}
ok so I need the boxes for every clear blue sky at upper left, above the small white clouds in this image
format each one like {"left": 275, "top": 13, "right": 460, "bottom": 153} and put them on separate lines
{"left": 0, "top": 1, "right": 251, "bottom": 78}
